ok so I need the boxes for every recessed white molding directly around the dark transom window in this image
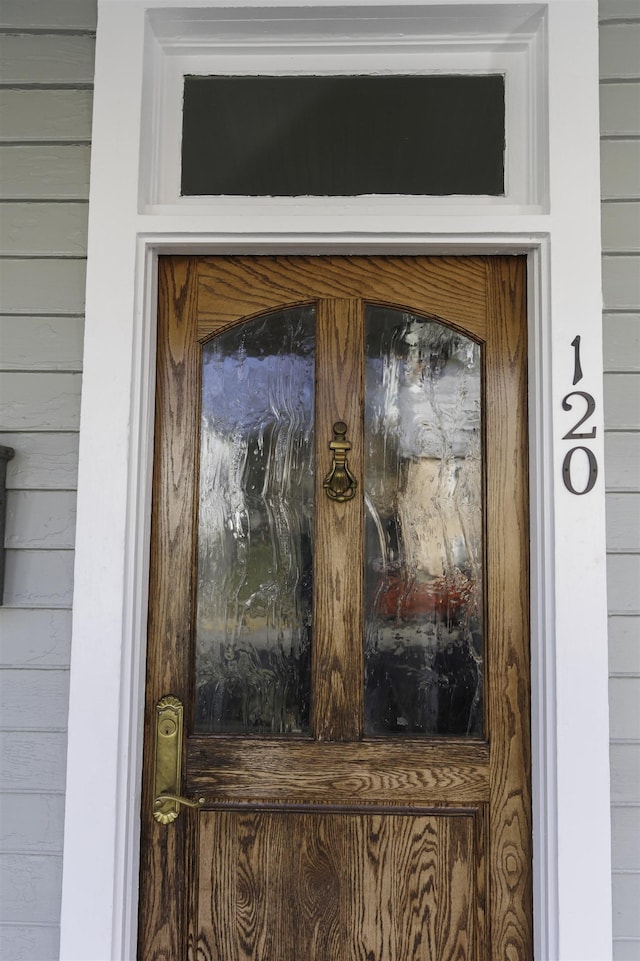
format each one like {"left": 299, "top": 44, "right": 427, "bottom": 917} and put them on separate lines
{"left": 140, "top": 4, "right": 548, "bottom": 212}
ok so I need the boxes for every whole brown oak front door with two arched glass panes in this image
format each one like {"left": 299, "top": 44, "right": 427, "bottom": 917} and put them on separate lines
{"left": 139, "top": 257, "right": 532, "bottom": 961}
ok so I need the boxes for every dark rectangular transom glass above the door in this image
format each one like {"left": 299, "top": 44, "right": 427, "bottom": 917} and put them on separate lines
{"left": 181, "top": 74, "right": 505, "bottom": 197}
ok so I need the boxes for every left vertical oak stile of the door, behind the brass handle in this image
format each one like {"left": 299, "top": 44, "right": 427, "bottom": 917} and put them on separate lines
{"left": 139, "top": 257, "right": 198, "bottom": 961}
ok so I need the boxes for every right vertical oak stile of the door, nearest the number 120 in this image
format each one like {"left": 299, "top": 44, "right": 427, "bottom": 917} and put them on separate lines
{"left": 486, "top": 257, "right": 533, "bottom": 961}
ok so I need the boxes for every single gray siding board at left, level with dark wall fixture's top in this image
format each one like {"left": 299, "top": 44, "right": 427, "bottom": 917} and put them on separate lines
{"left": 0, "top": 432, "right": 78, "bottom": 490}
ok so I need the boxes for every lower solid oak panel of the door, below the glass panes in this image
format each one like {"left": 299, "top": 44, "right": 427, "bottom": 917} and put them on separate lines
{"left": 195, "top": 811, "right": 482, "bottom": 961}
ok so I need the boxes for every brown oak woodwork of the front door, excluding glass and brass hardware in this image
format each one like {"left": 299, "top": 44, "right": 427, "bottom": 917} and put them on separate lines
{"left": 139, "top": 257, "right": 532, "bottom": 961}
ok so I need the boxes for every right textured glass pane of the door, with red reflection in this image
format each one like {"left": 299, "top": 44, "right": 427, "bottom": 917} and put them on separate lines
{"left": 365, "top": 307, "right": 483, "bottom": 736}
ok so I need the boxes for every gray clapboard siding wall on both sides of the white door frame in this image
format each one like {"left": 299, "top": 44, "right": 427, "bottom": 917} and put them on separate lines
{"left": 0, "top": 0, "right": 640, "bottom": 961}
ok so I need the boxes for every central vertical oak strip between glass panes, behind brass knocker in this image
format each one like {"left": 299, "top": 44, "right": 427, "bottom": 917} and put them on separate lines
{"left": 311, "top": 298, "right": 364, "bottom": 741}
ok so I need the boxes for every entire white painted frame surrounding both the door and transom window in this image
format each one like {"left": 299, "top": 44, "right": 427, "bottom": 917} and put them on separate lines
{"left": 60, "top": 0, "right": 612, "bottom": 961}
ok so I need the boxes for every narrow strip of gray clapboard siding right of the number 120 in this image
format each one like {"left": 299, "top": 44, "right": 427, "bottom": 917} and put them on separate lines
{"left": 600, "top": 0, "right": 640, "bottom": 961}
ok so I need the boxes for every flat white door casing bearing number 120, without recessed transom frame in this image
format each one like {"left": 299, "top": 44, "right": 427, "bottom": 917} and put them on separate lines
{"left": 61, "top": 0, "right": 611, "bottom": 961}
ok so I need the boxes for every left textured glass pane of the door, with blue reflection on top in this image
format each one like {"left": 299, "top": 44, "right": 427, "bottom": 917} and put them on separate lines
{"left": 195, "top": 307, "right": 315, "bottom": 734}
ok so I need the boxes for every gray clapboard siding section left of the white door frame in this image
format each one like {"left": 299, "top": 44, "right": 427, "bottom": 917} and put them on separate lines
{"left": 0, "top": 0, "right": 96, "bottom": 961}
